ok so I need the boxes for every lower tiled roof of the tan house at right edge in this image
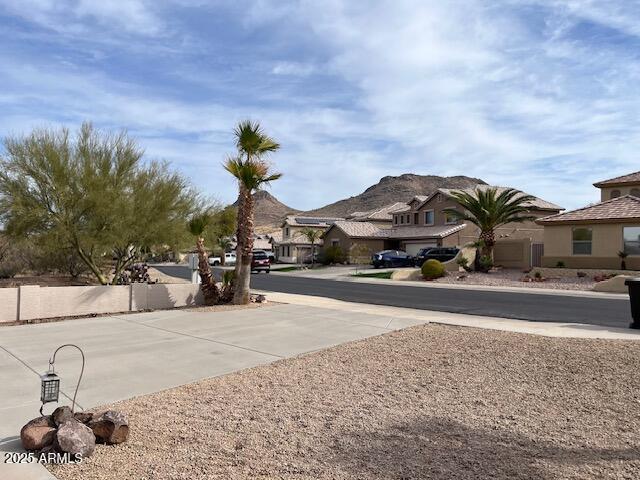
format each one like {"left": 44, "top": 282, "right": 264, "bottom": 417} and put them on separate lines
{"left": 537, "top": 195, "right": 640, "bottom": 225}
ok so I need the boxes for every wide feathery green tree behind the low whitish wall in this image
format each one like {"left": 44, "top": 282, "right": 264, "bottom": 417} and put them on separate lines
{"left": 0, "top": 123, "right": 197, "bottom": 285}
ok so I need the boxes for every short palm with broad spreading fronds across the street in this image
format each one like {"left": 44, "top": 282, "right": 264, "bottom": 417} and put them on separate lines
{"left": 443, "top": 187, "right": 536, "bottom": 260}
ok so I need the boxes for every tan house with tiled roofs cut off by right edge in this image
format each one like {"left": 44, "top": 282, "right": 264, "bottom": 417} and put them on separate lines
{"left": 538, "top": 172, "right": 640, "bottom": 270}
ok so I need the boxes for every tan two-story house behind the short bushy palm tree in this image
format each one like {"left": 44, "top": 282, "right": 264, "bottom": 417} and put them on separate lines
{"left": 325, "top": 185, "right": 562, "bottom": 267}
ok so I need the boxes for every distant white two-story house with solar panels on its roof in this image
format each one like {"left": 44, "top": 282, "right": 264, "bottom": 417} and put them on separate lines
{"left": 271, "top": 215, "right": 344, "bottom": 263}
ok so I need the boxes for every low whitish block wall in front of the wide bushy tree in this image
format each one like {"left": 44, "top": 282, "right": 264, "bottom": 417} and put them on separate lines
{"left": 0, "top": 283, "right": 203, "bottom": 322}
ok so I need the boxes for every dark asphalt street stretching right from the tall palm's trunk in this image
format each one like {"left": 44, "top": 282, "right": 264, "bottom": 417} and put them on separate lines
{"left": 251, "top": 273, "right": 631, "bottom": 328}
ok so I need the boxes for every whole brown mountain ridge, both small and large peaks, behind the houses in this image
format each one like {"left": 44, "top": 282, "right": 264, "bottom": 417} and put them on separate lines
{"left": 234, "top": 173, "right": 486, "bottom": 230}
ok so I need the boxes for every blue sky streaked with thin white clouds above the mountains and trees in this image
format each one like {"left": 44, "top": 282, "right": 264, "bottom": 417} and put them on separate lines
{"left": 0, "top": 0, "right": 640, "bottom": 209}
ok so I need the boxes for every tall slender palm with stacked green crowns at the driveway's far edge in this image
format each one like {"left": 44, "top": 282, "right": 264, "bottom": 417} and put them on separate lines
{"left": 224, "top": 120, "right": 282, "bottom": 305}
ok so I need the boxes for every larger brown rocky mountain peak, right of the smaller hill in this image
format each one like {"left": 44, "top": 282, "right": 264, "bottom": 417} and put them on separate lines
{"left": 305, "top": 173, "right": 486, "bottom": 217}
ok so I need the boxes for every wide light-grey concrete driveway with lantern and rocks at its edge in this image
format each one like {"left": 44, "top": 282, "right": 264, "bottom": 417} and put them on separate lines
{"left": 0, "top": 304, "right": 426, "bottom": 479}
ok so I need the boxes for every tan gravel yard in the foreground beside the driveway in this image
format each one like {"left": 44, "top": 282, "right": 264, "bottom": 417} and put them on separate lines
{"left": 49, "top": 325, "right": 640, "bottom": 480}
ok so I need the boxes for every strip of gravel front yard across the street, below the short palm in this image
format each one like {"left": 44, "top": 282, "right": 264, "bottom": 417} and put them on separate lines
{"left": 435, "top": 269, "right": 596, "bottom": 290}
